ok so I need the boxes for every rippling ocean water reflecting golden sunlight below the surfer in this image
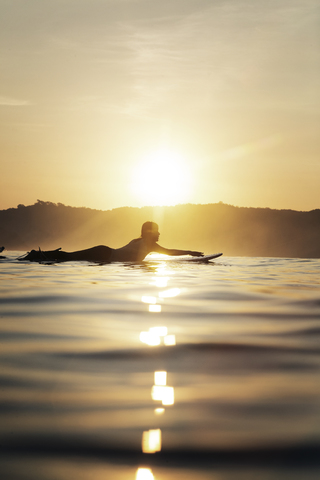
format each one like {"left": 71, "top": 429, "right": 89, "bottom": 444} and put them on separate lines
{"left": 0, "top": 252, "right": 320, "bottom": 480}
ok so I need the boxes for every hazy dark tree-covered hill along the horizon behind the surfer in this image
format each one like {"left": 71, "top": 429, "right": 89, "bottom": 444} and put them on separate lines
{"left": 0, "top": 200, "right": 320, "bottom": 258}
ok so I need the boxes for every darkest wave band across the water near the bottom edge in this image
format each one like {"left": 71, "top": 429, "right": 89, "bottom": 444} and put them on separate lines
{"left": 1, "top": 435, "right": 320, "bottom": 468}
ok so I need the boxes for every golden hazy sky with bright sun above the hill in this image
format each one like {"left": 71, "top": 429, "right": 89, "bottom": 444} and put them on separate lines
{"left": 0, "top": 0, "right": 320, "bottom": 210}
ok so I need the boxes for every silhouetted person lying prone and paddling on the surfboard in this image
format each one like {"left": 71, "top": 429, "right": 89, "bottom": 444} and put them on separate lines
{"left": 20, "top": 222, "right": 203, "bottom": 263}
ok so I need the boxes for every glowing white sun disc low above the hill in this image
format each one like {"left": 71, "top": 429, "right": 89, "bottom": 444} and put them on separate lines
{"left": 132, "top": 149, "right": 191, "bottom": 205}
